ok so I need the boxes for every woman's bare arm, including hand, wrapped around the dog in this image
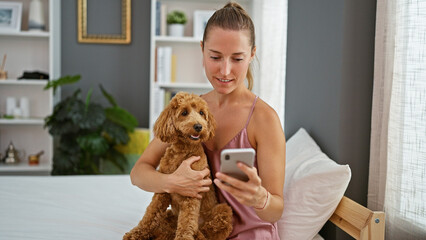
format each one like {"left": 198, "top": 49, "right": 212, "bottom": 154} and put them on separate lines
{"left": 130, "top": 138, "right": 211, "bottom": 198}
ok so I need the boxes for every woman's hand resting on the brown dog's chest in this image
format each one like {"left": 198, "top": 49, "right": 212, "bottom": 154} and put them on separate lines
{"left": 166, "top": 156, "right": 212, "bottom": 199}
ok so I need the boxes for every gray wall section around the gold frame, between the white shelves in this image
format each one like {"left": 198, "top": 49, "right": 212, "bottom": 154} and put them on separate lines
{"left": 61, "top": 0, "right": 151, "bottom": 127}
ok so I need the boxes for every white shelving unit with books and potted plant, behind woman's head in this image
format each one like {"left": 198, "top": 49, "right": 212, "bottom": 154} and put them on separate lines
{"left": 149, "top": 0, "right": 257, "bottom": 133}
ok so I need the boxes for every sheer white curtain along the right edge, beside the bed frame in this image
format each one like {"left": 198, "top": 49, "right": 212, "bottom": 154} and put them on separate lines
{"left": 368, "top": 0, "right": 426, "bottom": 239}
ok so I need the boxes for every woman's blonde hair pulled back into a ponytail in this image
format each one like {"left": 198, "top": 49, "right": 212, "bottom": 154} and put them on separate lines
{"left": 203, "top": 2, "right": 256, "bottom": 90}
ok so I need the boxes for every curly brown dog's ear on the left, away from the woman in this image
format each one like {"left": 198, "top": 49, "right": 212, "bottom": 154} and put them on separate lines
{"left": 154, "top": 100, "right": 177, "bottom": 143}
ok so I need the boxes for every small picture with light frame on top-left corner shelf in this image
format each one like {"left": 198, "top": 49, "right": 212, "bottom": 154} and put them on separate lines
{"left": 0, "top": 2, "right": 22, "bottom": 32}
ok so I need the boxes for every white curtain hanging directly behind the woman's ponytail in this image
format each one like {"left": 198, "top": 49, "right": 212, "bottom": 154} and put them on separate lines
{"left": 254, "top": 0, "right": 287, "bottom": 127}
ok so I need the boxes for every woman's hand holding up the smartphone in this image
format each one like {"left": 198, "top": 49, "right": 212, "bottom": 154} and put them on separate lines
{"left": 214, "top": 163, "right": 268, "bottom": 209}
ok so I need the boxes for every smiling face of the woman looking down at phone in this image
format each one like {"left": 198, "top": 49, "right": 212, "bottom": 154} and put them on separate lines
{"left": 203, "top": 27, "right": 255, "bottom": 94}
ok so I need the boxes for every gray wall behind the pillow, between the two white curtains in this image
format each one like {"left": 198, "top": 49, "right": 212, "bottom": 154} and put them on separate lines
{"left": 285, "top": 0, "right": 376, "bottom": 239}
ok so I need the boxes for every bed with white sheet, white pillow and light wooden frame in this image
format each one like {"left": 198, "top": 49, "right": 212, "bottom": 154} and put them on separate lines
{"left": 0, "top": 129, "right": 385, "bottom": 240}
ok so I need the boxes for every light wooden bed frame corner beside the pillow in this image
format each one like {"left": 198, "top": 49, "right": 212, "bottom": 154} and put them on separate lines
{"left": 329, "top": 197, "right": 385, "bottom": 240}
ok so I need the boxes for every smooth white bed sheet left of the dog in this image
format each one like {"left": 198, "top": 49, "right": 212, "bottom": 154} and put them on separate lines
{"left": 0, "top": 175, "right": 323, "bottom": 240}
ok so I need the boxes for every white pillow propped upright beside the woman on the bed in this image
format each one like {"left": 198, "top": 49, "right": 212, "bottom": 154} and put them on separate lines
{"left": 278, "top": 128, "right": 351, "bottom": 240}
